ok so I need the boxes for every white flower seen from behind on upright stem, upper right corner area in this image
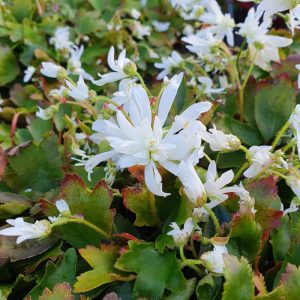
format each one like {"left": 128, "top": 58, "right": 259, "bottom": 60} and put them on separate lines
{"left": 238, "top": 8, "right": 293, "bottom": 70}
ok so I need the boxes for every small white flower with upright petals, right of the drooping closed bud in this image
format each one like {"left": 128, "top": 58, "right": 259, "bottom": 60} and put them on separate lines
{"left": 204, "top": 161, "right": 234, "bottom": 203}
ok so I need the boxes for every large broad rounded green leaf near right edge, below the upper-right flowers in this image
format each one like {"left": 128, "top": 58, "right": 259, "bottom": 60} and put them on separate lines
{"left": 255, "top": 76, "right": 296, "bottom": 141}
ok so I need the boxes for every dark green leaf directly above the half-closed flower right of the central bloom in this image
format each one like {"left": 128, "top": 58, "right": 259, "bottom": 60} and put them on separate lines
{"left": 216, "top": 115, "right": 264, "bottom": 146}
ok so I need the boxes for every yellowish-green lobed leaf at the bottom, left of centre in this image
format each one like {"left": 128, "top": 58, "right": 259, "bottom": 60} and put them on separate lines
{"left": 74, "top": 245, "right": 123, "bottom": 293}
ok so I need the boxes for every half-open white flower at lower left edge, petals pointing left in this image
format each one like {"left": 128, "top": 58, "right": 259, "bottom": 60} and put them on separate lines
{"left": 0, "top": 218, "right": 51, "bottom": 244}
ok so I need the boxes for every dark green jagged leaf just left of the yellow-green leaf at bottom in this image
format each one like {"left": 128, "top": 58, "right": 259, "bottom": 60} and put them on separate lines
{"left": 28, "top": 248, "right": 77, "bottom": 299}
